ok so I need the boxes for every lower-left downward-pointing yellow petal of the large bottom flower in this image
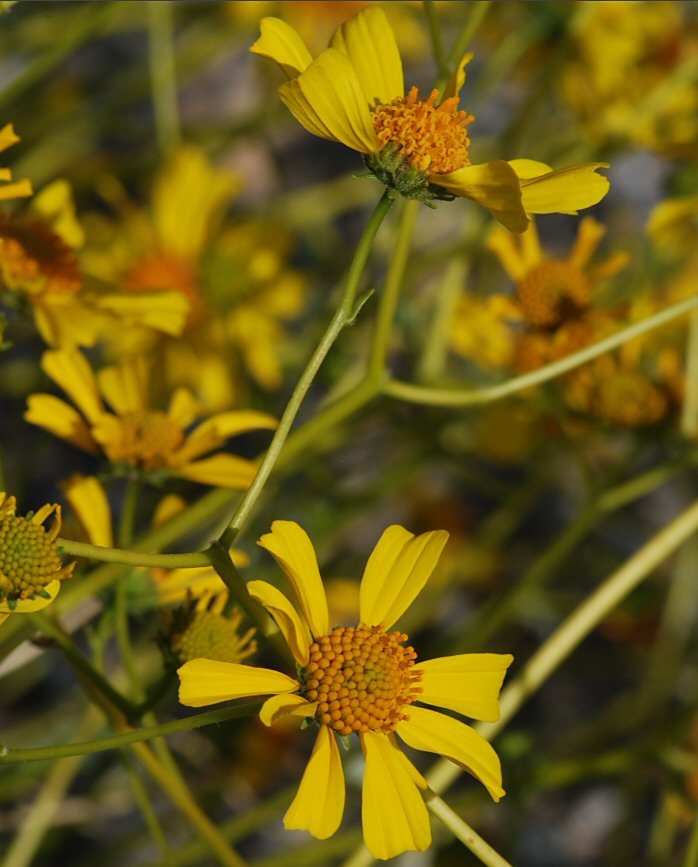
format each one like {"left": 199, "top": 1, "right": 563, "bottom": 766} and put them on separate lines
{"left": 284, "top": 726, "right": 344, "bottom": 840}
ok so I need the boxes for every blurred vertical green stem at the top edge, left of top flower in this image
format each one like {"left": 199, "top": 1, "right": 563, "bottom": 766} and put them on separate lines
{"left": 148, "top": 0, "right": 181, "bottom": 154}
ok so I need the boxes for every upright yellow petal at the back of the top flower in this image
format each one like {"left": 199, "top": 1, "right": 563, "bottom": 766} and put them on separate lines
{"left": 330, "top": 6, "right": 405, "bottom": 108}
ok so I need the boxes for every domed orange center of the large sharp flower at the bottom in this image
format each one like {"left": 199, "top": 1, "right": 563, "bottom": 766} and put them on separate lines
{"left": 301, "top": 625, "right": 421, "bottom": 735}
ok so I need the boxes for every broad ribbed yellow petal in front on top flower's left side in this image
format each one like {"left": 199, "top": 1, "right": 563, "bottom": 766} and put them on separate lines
{"left": 279, "top": 48, "right": 378, "bottom": 154}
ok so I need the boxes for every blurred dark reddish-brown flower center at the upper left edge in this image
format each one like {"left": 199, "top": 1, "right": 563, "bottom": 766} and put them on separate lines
{"left": 0, "top": 214, "right": 81, "bottom": 295}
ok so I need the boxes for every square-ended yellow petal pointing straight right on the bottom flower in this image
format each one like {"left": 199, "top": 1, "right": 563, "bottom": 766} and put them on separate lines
{"left": 419, "top": 653, "right": 514, "bottom": 722}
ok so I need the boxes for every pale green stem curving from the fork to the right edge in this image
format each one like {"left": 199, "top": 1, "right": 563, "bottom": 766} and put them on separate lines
{"left": 385, "top": 296, "right": 698, "bottom": 407}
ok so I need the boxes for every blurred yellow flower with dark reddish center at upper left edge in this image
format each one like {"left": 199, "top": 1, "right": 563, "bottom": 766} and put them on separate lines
{"left": 0, "top": 180, "right": 187, "bottom": 347}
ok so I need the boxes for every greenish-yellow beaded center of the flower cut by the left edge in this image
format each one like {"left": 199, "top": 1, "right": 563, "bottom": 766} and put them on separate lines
{"left": 0, "top": 515, "right": 61, "bottom": 600}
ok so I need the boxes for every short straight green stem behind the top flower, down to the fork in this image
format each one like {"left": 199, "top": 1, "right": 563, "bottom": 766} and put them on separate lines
{"left": 366, "top": 202, "right": 416, "bottom": 381}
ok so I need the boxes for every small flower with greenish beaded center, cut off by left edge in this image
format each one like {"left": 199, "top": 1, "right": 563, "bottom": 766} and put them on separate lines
{"left": 0, "top": 491, "right": 75, "bottom": 623}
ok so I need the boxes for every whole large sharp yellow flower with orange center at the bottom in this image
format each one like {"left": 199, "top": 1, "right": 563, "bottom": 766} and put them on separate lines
{"left": 179, "top": 521, "right": 513, "bottom": 858}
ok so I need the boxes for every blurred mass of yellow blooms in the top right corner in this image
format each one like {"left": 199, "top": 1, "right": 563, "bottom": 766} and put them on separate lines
{"left": 560, "top": 0, "right": 698, "bottom": 155}
